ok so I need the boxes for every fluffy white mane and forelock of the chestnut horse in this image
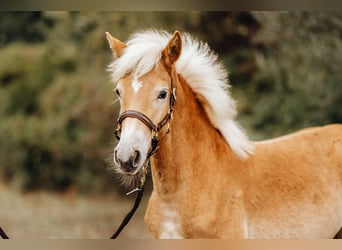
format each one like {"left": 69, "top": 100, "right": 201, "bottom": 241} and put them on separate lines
{"left": 109, "top": 30, "right": 253, "bottom": 159}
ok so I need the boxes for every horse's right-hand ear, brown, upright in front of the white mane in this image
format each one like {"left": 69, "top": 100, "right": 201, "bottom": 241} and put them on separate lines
{"left": 162, "top": 31, "right": 182, "bottom": 66}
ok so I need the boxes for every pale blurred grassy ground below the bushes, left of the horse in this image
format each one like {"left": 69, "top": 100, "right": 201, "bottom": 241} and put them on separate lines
{"left": 0, "top": 185, "right": 149, "bottom": 239}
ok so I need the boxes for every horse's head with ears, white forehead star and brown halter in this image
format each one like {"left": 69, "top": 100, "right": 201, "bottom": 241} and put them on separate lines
{"left": 106, "top": 32, "right": 182, "bottom": 184}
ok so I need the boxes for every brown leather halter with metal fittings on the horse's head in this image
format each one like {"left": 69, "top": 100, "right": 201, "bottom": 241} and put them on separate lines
{"left": 115, "top": 77, "right": 176, "bottom": 158}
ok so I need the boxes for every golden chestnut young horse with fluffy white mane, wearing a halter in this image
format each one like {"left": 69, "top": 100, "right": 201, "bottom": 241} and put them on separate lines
{"left": 106, "top": 30, "right": 342, "bottom": 239}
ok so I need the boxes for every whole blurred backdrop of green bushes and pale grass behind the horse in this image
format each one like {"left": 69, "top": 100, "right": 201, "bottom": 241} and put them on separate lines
{"left": 0, "top": 11, "right": 342, "bottom": 238}
